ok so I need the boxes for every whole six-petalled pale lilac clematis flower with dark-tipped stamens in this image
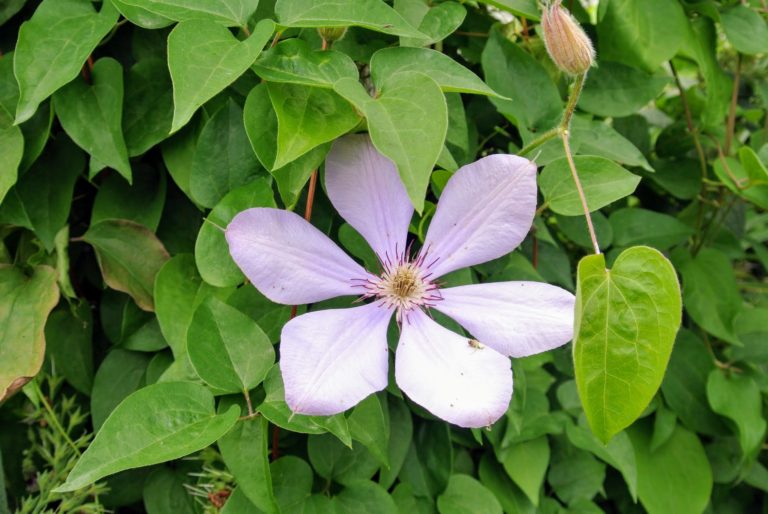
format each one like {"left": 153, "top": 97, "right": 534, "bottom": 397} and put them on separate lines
{"left": 226, "top": 135, "right": 574, "bottom": 427}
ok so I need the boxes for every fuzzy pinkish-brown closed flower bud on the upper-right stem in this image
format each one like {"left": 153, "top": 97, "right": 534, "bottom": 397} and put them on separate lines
{"left": 541, "top": 0, "right": 595, "bottom": 75}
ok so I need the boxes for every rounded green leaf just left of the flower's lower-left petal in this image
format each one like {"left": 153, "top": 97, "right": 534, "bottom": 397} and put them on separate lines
{"left": 187, "top": 298, "right": 275, "bottom": 393}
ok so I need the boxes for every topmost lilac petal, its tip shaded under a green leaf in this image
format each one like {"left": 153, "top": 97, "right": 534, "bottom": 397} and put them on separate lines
{"left": 325, "top": 135, "right": 413, "bottom": 261}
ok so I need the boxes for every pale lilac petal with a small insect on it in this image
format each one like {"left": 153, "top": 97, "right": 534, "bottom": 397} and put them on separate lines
{"left": 395, "top": 309, "right": 512, "bottom": 427}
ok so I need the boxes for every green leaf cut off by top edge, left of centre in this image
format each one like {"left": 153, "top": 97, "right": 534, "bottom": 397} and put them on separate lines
{"left": 109, "top": 0, "right": 259, "bottom": 28}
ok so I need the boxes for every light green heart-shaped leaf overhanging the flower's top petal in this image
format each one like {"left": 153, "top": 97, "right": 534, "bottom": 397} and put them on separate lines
{"left": 334, "top": 71, "right": 448, "bottom": 212}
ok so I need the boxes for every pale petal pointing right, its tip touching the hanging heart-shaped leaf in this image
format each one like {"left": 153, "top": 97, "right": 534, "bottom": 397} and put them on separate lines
{"left": 435, "top": 282, "right": 575, "bottom": 357}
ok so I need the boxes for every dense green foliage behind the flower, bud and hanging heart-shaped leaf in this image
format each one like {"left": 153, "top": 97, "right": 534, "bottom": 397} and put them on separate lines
{"left": 0, "top": 0, "right": 768, "bottom": 514}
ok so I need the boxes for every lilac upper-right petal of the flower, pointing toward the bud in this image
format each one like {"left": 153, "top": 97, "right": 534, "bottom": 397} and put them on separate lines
{"left": 424, "top": 155, "right": 536, "bottom": 277}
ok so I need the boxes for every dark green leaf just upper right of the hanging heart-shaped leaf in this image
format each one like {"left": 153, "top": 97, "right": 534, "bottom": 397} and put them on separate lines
{"left": 609, "top": 208, "right": 693, "bottom": 250}
